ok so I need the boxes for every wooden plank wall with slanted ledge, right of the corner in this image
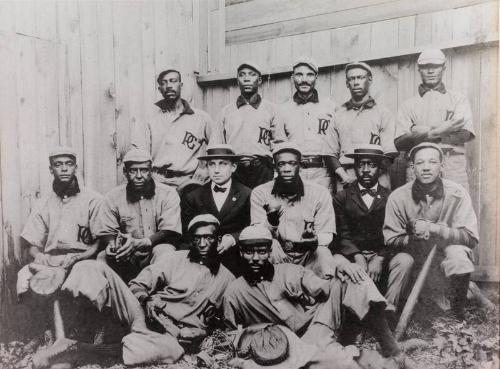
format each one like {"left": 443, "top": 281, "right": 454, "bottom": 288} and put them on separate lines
{"left": 198, "top": 0, "right": 500, "bottom": 281}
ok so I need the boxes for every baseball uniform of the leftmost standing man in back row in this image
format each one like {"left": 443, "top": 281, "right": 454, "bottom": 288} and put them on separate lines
{"left": 132, "top": 100, "right": 213, "bottom": 187}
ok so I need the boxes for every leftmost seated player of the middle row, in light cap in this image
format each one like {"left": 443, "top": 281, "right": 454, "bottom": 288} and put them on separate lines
{"left": 17, "top": 147, "right": 101, "bottom": 344}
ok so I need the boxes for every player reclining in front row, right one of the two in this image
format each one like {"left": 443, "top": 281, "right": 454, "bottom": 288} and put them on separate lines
{"left": 223, "top": 225, "right": 418, "bottom": 368}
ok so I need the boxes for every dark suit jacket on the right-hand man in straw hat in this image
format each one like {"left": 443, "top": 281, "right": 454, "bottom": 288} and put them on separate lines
{"left": 333, "top": 182, "right": 390, "bottom": 258}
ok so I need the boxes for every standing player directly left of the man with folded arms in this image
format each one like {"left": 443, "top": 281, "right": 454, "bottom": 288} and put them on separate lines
{"left": 335, "top": 62, "right": 397, "bottom": 191}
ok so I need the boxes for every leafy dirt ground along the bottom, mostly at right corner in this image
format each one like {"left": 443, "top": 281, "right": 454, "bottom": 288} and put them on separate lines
{"left": 0, "top": 284, "right": 500, "bottom": 369}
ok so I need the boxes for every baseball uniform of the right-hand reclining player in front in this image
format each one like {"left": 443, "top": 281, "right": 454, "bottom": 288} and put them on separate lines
{"left": 223, "top": 264, "right": 385, "bottom": 342}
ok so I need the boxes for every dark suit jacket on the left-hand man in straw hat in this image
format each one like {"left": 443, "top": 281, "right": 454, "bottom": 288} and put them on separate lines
{"left": 181, "top": 178, "right": 252, "bottom": 241}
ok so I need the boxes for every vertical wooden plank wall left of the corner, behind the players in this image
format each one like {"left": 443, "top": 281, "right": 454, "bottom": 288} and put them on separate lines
{"left": 0, "top": 0, "right": 202, "bottom": 337}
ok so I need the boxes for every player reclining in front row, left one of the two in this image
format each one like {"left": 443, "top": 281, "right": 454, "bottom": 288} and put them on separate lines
{"left": 34, "top": 214, "right": 234, "bottom": 368}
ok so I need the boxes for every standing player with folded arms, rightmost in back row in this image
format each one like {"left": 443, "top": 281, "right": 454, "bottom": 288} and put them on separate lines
{"left": 394, "top": 49, "right": 475, "bottom": 190}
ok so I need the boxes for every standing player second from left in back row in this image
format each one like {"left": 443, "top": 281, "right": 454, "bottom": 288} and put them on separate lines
{"left": 210, "top": 62, "right": 286, "bottom": 188}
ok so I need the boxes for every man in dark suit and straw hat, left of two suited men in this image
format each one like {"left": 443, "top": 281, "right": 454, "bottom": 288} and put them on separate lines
{"left": 181, "top": 144, "right": 252, "bottom": 276}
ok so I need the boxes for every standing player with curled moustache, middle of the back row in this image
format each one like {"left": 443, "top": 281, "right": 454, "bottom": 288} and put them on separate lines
{"left": 280, "top": 57, "right": 351, "bottom": 194}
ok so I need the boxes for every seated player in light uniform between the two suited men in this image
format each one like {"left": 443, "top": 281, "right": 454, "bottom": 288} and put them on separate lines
{"left": 250, "top": 142, "right": 343, "bottom": 278}
